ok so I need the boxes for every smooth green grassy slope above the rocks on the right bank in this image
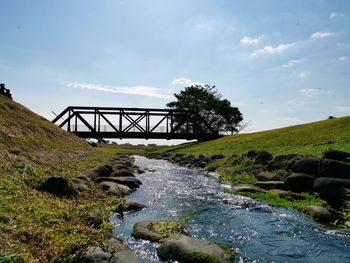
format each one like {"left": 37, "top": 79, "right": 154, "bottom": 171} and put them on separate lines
{"left": 166, "top": 116, "right": 350, "bottom": 156}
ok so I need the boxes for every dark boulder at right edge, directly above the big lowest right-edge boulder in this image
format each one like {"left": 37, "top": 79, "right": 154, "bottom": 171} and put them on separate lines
{"left": 318, "top": 159, "right": 350, "bottom": 179}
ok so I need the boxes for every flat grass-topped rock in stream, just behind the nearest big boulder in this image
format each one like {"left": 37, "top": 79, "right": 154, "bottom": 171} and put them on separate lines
{"left": 131, "top": 220, "right": 187, "bottom": 242}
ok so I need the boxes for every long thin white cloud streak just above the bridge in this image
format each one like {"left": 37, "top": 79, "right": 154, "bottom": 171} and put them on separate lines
{"left": 64, "top": 82, "right": 172, "bottom": 99}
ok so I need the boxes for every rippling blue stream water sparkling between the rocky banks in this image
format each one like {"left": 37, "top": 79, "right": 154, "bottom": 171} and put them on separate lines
{"left": 111, "top": 156, "right": 350, "bottom": 263}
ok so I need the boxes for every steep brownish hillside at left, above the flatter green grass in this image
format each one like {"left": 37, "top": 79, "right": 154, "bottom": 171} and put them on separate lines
{"left": 0, "top": 96, "right": 93, "bottom": 167}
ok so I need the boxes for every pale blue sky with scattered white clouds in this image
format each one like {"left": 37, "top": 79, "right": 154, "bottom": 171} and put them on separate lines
{"left": 0, "top": 0, "right": 350, "bottom": 144}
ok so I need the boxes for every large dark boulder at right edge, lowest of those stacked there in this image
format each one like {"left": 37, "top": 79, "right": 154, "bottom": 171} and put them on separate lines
{"left": 314, "top": 177, "right": 350, "bottom": 208}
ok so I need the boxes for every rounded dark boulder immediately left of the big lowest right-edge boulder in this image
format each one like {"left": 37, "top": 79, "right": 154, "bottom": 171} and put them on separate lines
{"left": 284, "top": 173, "right": 315, "bottom": 193}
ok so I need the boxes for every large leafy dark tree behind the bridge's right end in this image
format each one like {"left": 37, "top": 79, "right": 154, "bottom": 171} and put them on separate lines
{"left": 167, "top": 85, "right": 243, "bottom": 133}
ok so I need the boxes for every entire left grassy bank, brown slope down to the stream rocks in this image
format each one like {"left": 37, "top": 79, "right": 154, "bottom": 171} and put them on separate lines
{"left": 0, "top": 96, "right": 153, "bottom": 263}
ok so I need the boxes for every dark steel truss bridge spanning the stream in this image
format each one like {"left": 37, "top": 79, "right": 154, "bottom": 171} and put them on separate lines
{"left": 52, "top": 106, "right": 219, "bottom": 140}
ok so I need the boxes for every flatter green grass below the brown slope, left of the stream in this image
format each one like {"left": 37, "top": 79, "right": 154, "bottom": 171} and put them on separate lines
{"left": 0, "top": 152, "right": 133, "bottom": 262}
